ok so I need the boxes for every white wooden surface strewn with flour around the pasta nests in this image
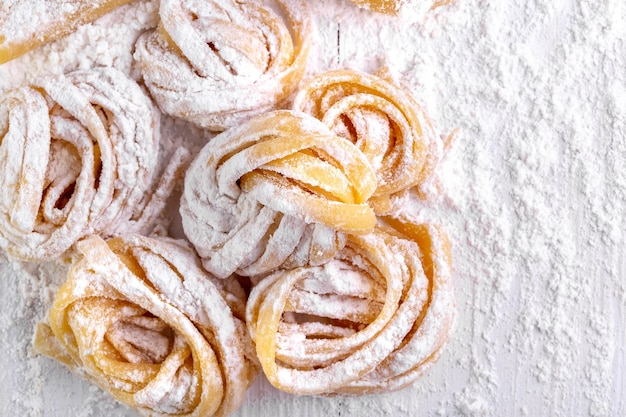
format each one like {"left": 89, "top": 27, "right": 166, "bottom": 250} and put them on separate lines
{"left": 0, "top": 0, "right": 626, "bottom": 417}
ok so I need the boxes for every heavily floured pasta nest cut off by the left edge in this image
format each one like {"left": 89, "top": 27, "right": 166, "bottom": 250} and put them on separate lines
{"left": 0, "top": 68, "right": 188, "bottom": 260}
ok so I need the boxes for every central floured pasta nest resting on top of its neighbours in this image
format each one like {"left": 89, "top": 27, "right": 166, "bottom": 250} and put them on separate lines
{"left": 180, "top": 110, "right": 376, "bottom": 277}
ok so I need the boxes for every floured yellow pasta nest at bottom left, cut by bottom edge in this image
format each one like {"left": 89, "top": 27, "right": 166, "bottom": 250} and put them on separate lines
{"left": 35, "top": 235, "right": 258, "bottom": 417}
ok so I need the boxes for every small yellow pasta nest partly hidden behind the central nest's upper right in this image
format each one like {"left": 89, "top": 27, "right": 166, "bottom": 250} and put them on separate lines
{"left": 293, "top": 70, "right": 444, "bottom": 214}
